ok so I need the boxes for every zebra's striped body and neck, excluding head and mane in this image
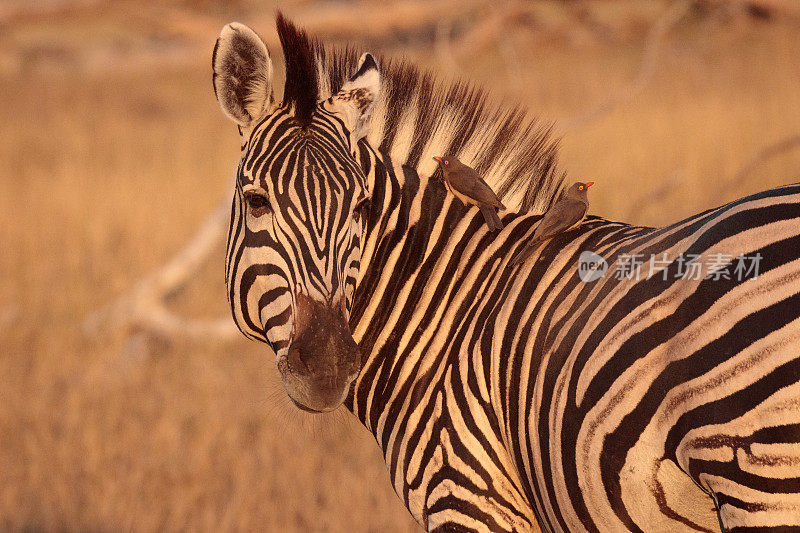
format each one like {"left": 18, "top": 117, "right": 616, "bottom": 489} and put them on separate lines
{"left": 354, "top": 153, "right": 800, "bottom": 531}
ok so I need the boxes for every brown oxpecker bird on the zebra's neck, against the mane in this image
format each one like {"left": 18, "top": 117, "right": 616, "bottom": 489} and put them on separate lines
{"left": 434, "top": 157, "right": 506, "bottom": 231}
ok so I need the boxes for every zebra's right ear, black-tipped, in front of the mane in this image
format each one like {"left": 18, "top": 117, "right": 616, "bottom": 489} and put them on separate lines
{"left": 333, "top": 54, "right": 381, "bottom": 146}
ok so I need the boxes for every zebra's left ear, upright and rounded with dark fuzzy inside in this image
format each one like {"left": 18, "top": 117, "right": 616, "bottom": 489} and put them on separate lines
{"left": 211, "top": 22, "right": 272, "bottom": 129}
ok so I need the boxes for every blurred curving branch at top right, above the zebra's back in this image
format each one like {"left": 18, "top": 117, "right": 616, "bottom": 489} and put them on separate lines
{"left": 558, "top": 0, "right": 694, "bottom": 131}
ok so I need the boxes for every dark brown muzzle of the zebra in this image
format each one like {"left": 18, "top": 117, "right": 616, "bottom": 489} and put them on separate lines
{"left": 278, "top": 295, "right": 362, "bottom": 413}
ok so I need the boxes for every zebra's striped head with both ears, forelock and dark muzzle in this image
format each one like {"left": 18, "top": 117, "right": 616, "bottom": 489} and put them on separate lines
{"left": 212, "top": 15, "right": 380, "bottom": 412}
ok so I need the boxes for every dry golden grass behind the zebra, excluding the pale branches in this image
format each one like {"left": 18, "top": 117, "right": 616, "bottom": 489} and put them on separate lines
{"left": 0, "top": 2, "right": 800, "bottom": 531}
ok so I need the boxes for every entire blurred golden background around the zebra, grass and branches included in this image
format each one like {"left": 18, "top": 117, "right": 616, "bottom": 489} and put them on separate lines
{"left": 0, "top": 0, "right": 800, "bottom": 532}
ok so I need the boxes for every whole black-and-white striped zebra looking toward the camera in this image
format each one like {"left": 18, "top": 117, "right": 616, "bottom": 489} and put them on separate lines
{"left": 212, "top": 13, "right": 800, "bottom": 531}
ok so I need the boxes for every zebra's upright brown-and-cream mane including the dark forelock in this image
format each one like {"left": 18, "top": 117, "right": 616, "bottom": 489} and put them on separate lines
{"left": 277, "top": 13, "right": 564, "bottom": 213}
